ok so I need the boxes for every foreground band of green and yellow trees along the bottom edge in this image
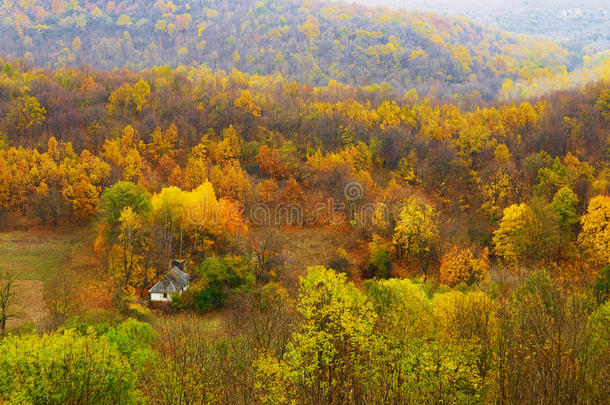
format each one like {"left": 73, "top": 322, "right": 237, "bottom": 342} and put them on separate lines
{"left": 0, "top": 266, "right": 610, "bottom": 404}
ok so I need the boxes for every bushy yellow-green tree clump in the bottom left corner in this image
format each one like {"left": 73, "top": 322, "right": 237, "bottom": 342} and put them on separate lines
{"left": 0, "top": 330, "right": 139, "bottom": 404}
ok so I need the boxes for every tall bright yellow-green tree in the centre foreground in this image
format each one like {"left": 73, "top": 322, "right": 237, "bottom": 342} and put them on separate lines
{"left": 274, "top": 266, "right": 376, "bottom": 403}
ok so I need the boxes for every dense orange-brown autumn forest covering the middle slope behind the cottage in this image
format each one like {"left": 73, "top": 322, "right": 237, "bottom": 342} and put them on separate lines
{"left": 0, "top": 56, "right": 610, "bottom": 280}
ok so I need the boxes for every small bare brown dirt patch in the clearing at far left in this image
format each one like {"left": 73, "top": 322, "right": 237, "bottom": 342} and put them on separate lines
{"left": 7, "top": 280, "right": 51, "bottom": 330}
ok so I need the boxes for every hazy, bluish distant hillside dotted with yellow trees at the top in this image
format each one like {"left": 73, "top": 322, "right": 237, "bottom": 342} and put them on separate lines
{"left": 0, "top": 0, "right": 599, "bottom": 99}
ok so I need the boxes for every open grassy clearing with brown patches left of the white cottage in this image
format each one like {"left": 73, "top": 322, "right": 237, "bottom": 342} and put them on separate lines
{"left": 0, "top": 226, "right": 109, "bottom": 330}
